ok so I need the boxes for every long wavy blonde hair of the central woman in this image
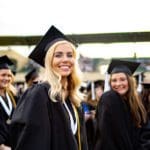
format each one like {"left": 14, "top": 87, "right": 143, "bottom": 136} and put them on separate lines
{"left": 44, "top": 40, "right": 81, "bottom": 106}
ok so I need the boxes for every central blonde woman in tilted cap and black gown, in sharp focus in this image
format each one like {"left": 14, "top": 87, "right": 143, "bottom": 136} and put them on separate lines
{"left": 11, "top": 26, "right": 87, "bottom": 150}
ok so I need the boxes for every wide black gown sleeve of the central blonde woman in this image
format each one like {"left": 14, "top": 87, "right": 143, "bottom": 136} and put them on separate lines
{"left": 11, "top": 85, "right": 51, "bottom": 150}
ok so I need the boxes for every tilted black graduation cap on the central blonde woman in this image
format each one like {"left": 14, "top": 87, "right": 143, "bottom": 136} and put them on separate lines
{"left": 29, "top": 26, "right": 73, "bottom": 67}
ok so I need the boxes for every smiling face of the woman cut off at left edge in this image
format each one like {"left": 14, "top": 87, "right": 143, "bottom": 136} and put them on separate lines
{"left": 0, "top": 69, "right": 12, "bottom": 89}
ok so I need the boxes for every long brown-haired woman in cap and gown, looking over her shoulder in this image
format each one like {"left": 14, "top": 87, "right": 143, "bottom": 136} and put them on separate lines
{"left": 94, "top": 59, "right": 146, "bottom": 150}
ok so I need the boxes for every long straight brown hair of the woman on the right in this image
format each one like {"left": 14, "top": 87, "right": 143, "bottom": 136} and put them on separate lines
{"left": 110, "top": 74, "right": 146, "bottom": 127}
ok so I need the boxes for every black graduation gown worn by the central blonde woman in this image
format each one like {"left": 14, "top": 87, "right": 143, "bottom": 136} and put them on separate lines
{"left": 11, "top": 83, "right": 87, "bottom": 150}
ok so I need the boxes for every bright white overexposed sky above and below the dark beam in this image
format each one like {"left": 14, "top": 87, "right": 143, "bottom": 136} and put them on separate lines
{"left": 0, "top": 0, "right": 150, "bottom": 57}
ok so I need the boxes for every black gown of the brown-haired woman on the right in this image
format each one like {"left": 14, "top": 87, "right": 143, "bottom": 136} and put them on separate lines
{"left": 94, "top": 91, "right": 142, "bottom": 150}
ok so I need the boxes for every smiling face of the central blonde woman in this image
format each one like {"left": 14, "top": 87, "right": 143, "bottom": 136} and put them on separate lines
{"left": 52, "top": 43, "right": 75, "bottom": 77}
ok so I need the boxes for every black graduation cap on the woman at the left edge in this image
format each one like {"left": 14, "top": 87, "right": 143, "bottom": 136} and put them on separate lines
{"left": 0, "top": 55, "right": 13, "bottom": 69}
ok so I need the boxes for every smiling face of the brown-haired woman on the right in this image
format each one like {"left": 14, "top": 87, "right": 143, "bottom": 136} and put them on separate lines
{"left": 110, "top": 73, "right": 129, "bottom": 95}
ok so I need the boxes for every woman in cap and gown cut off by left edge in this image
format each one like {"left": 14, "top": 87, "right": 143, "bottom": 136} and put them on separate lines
{"left": 0, "top": 55, "right": 16, "bottom": 149}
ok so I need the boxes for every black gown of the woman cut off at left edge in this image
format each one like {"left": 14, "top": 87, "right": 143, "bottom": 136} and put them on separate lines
{"left": 0, "top": 92, "right": 15, "bottom": 145}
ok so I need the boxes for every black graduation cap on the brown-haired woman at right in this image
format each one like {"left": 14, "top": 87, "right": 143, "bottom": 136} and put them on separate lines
{"left": 107, "top": 59, "right": 140, "bottom": 75}
